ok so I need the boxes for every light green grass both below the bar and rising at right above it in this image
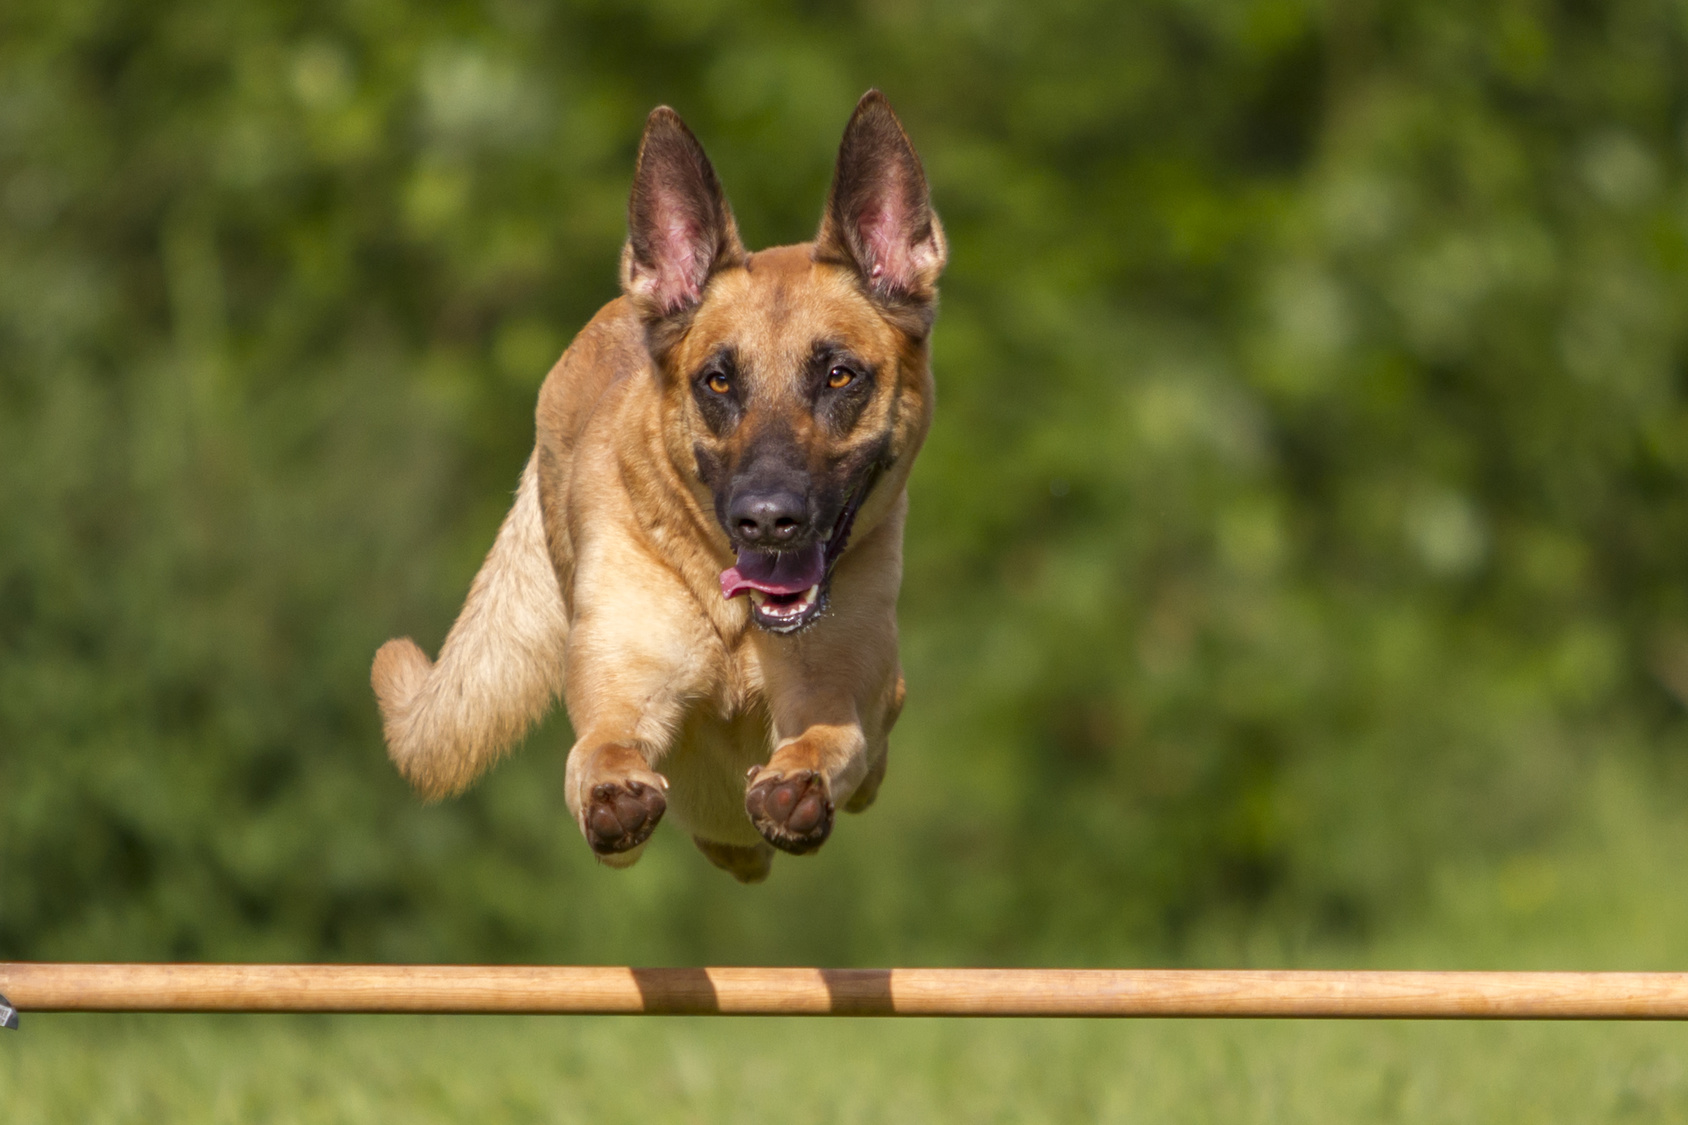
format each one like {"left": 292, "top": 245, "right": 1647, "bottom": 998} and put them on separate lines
{"left": 13, "top": 756, "right": 1688, "bottom": 1125}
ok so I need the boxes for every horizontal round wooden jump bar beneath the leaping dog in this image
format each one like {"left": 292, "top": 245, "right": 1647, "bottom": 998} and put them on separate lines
{"left": 0, "top": 961, "right": 1688, "bottom": 1020}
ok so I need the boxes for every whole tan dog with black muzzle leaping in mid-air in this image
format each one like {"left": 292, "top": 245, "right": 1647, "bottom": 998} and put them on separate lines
{"left": 371, "top": 91, "right": 947, "bottom": 882}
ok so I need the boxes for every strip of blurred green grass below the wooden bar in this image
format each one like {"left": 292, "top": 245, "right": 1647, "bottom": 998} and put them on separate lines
{"left": 0, "top": 1015, "right": 1688, "bottom": 1125}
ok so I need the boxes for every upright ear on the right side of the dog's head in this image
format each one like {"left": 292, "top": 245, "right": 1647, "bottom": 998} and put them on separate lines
{"left": 815, "top": 90, "right": 949, "bottom": 328}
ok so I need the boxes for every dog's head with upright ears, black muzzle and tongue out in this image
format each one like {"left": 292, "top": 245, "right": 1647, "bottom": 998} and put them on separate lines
{"left": 621, "top": 91, "right": 947, "bottom": 633}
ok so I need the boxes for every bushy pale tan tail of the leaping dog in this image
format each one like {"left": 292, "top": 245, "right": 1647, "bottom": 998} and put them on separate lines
{"left": 370, "top": 456, "right": 569, "bottom": 797}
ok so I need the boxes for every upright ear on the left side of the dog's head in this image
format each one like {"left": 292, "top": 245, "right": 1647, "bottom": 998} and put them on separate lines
{"left": 621, "top": 105, "right": 744, "bottom": 345}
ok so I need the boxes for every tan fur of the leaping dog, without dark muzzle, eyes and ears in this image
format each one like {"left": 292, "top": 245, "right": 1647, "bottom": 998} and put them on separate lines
{"left": 371, "top": 95, "right": 942, "bottom": 880}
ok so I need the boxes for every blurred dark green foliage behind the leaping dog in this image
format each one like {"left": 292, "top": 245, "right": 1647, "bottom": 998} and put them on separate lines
{"left": 0, "top": 0, "right": 1688, "bottom": 963}
